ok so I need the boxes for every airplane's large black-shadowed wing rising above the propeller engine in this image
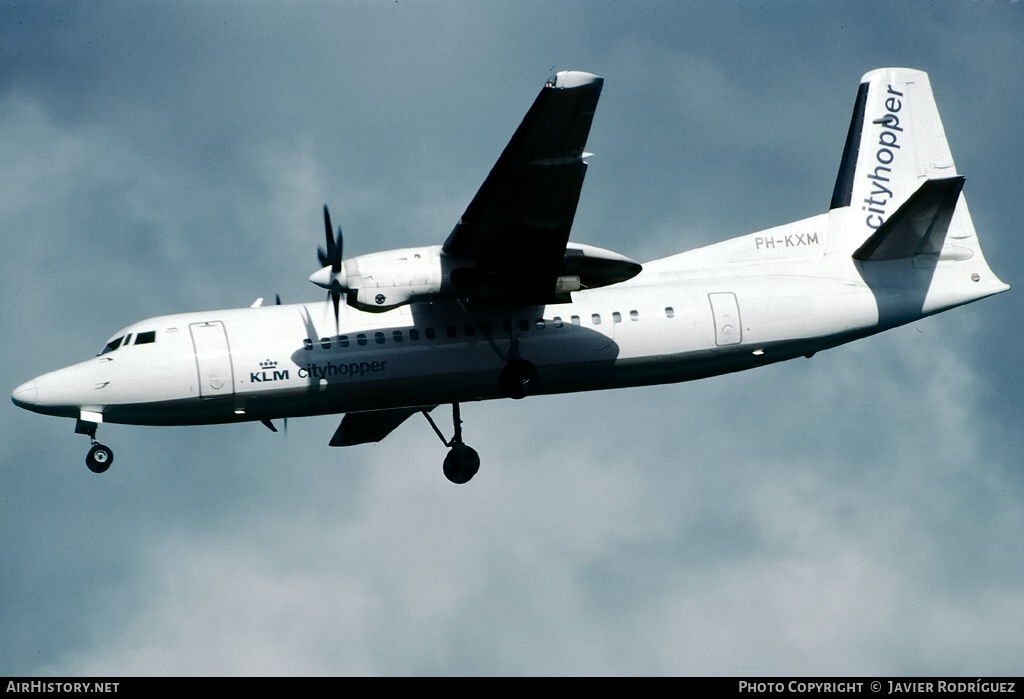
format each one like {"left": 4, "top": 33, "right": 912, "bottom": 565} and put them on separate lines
{"left": 443, "top": 71, "right": 604, "bottom": 305}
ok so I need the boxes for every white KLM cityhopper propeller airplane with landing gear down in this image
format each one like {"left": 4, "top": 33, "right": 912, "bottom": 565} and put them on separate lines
{"left": 11, "top": 68, "right": 1010, "bottom": 483}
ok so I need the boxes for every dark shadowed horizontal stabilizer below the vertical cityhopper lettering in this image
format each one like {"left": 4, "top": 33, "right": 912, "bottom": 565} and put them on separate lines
{"left": 853, "top": 177, "right": 964, "bottom": 262}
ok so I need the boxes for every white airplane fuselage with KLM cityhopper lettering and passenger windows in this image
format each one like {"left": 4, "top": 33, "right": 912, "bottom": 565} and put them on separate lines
{"left": 12, "top": 214, "right": 1007, "bottom": 425}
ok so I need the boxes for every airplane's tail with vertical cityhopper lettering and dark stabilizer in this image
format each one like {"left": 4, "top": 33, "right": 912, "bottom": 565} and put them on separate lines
{"left": 826, "top": 68, "right": 1009, "bottom": 308}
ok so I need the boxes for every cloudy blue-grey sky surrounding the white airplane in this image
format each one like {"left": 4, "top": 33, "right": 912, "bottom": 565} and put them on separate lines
{"left": 0, "top": 0, "right": 1024, "bottom": 676}
